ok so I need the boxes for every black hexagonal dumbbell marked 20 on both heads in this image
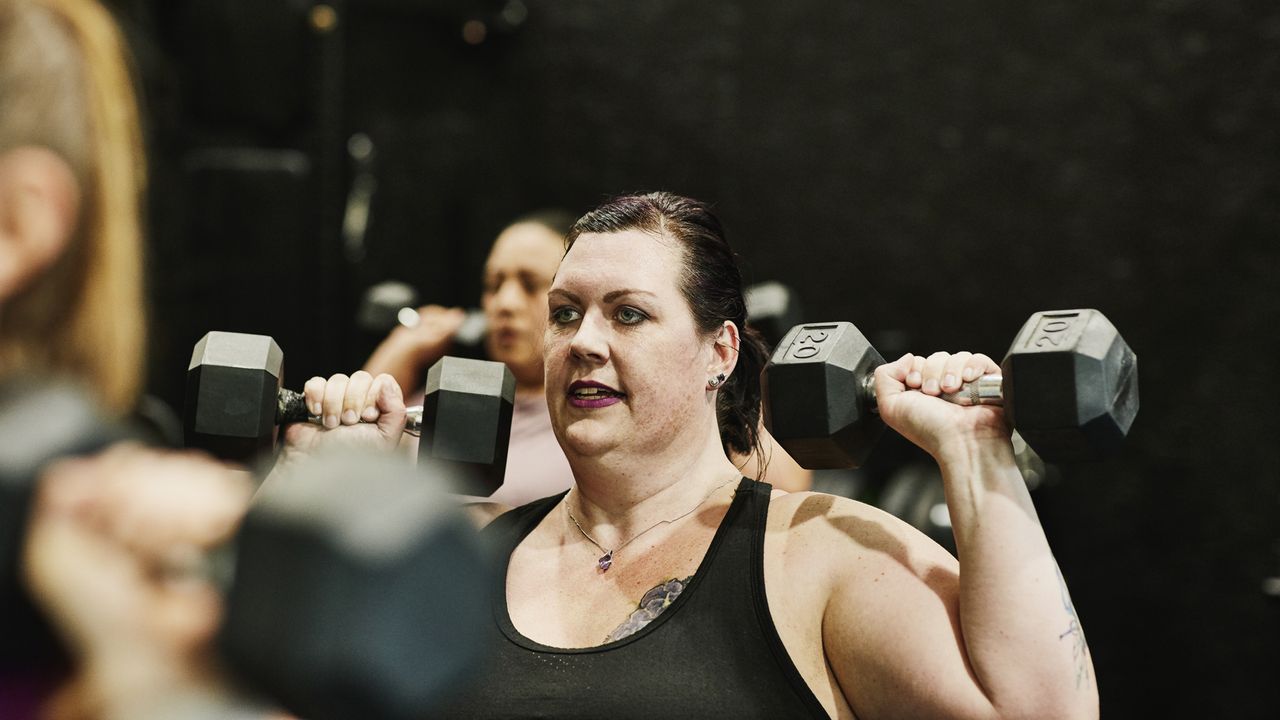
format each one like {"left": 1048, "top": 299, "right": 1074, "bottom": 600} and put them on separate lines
{"left": 765, "top": 310, "right": 1138, "bottom": 468}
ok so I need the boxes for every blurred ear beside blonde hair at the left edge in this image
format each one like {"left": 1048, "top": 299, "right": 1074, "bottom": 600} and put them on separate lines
{"left": 0, "top": 146, "right": 79, "bottom": 301}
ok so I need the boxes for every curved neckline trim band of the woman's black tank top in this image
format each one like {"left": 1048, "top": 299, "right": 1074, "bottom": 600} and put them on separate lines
{"left": 493, "top": 478, "right": 755, "bottom": 655}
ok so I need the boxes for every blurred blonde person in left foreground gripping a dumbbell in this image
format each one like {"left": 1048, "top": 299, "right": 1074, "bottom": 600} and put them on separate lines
{"left": 0, "top": 0, "right": 248, "bottom": 720}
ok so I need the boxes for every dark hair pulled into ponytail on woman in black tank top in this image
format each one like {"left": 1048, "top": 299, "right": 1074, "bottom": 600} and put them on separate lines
{"left": 566, "top": 192, "right": 768, "bottom": 469}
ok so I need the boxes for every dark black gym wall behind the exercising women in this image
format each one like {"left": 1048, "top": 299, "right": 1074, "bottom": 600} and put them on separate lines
{"left": 115, "top": 0, "right": 1280, "bottom": 717}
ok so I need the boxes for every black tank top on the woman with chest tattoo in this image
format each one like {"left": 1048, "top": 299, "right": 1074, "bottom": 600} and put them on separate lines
{"left": 440, "top": 478, "right": 827, "bottom": 720}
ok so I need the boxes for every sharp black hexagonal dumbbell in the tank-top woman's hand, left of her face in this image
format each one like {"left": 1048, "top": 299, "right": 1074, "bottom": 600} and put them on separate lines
{"left": 183, "top": 331, "right": 516, "bottom": 496}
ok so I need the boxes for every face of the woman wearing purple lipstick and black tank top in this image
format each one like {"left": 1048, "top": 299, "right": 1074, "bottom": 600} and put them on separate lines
{"left": 544, "top": 231, "right": 714, "bottom": 461}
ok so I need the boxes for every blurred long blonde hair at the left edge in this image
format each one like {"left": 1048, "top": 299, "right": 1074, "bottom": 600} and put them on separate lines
{"left": 0, "top": 0, "right": 146, "bottom": 413}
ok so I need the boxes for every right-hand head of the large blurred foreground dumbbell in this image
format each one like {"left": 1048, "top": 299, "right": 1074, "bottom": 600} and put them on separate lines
{"left": 217, "top": 450, "right": 492, "bottom": 720}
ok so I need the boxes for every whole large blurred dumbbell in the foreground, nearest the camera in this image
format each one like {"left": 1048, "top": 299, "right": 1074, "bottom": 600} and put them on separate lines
{"left": 0, "top": 383, "right": 490, "bottom": 720}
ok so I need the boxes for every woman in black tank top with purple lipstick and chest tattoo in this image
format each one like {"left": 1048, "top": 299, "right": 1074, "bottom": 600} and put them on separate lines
{"left": 307, "top": 193, "right": 1098, "bottom": 717}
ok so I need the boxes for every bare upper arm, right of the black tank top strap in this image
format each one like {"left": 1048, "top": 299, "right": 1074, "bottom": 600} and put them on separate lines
{"left": 822, "top": 503, "right": 995, "bottom": 719}
